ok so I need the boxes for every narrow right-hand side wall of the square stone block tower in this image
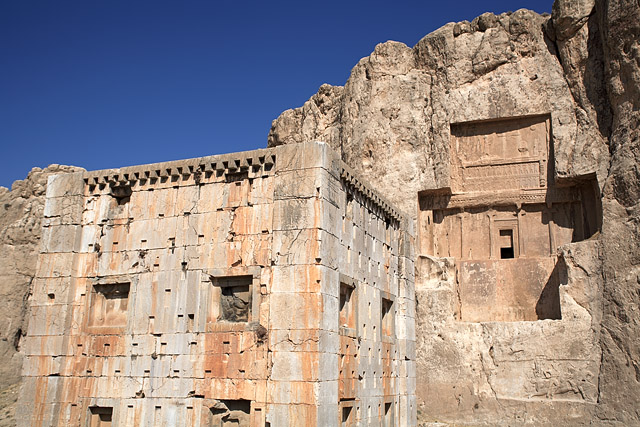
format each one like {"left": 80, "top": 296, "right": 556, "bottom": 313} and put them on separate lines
{"left": 329, "top": 165, "right": 417, "bottom": 426}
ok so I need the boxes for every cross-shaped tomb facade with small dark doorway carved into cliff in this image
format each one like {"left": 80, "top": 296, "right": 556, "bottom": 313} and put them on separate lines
{"left": 418, "top": 115, "right": 602, "bottom": 322}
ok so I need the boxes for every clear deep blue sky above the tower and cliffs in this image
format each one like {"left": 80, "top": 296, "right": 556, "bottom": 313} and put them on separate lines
{"left": 0, "top": 0, "right": 552, "bottom": 187}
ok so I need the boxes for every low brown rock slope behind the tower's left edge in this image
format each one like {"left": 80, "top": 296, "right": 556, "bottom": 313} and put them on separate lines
{"left": 0, "top": 165, "right": 82, "bottom": 425}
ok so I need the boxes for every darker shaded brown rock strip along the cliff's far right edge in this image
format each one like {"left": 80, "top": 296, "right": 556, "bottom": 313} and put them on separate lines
{"left": 596, "top": 0, "right": 640, "bottom": 424}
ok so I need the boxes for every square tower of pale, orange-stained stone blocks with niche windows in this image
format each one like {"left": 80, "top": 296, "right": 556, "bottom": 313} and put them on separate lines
{"left": 17, "top": 143, "right": 416, "bottom": 426}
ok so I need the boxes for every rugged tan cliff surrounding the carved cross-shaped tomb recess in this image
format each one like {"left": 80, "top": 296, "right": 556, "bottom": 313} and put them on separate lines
{"left": 268, "top": 0, "right": 640, "bottom": 424}
